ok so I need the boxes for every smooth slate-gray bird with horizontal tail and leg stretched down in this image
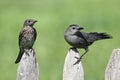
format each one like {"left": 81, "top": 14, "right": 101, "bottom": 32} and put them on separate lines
{"left": 64, "top": 24, "right": 112, "bottom": 65}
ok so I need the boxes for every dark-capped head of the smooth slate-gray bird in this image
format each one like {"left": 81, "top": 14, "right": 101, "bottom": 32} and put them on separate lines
{"left": 67, "top": 24, "right": 84, "bottom": 34}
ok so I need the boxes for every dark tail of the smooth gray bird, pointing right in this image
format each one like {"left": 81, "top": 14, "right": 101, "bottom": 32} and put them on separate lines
{"left": 90, "top": 32, "right": 112, "bottom": 40}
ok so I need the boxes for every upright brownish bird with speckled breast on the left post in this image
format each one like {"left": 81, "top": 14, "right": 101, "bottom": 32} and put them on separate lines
{"left": 15, "top": 19, "right": 37, "bottom": 64}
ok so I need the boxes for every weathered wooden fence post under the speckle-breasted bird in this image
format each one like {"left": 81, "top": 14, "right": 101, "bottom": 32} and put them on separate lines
{"left": 16, "top": 49, "right": 39, "bottom": 80}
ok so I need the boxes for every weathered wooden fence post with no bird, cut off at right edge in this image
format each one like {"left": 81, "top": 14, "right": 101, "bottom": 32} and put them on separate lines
{"left": 105, "top": 49, "right": 120, "bottom": 80}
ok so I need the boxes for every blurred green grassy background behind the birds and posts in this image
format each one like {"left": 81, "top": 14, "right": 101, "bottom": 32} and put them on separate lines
{"left": 0, "top": 0, "right": 120, "bottom": 80}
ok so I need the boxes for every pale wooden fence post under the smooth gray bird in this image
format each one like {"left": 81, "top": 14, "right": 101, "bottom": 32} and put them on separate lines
{"left": 63, "top": 48, "right": 84, "bottom": 80}
